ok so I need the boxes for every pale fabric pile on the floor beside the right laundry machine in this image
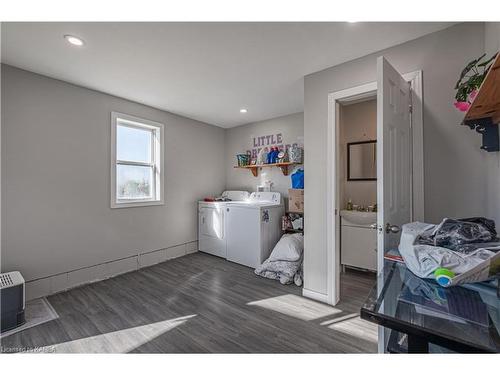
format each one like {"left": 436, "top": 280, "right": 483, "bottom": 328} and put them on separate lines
{"left": 255, "top": 233, "right": 304, "bottom": 286}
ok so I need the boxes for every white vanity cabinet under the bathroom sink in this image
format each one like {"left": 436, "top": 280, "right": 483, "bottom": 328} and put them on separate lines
{"left": 340, "top": 217, "right": 377, "bottom": 271}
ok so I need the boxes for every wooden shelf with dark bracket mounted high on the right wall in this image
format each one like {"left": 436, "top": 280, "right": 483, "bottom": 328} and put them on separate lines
{"left": 463, "top": 52, "right": 500, "bottom": 152}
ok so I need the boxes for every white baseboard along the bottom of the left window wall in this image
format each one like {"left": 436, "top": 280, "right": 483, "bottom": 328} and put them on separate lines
{"left": 25, "top": 241, "right": 198, "bottom": 301}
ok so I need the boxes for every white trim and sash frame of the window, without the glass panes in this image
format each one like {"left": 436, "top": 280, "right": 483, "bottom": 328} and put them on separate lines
{"left": 110, "top": 112, "right": 165, "bottom": 208}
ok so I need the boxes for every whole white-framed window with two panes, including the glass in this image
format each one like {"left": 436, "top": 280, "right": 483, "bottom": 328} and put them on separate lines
{"left": 111, "top": 112, "right": 164, "bottom": 208}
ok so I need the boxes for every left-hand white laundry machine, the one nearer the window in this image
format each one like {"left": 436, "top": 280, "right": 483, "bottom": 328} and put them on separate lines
{"left": 198, "top": 191, "right": 250, "bottom": 258}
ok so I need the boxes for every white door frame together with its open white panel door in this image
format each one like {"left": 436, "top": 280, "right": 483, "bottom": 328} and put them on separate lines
{"left": 327, "top": 56, "right": 424, "bottom": 352}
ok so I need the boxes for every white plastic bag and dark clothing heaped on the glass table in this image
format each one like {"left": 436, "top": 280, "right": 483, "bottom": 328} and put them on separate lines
{"left": 399, "top": 217, "right": 500, "bottom": 281}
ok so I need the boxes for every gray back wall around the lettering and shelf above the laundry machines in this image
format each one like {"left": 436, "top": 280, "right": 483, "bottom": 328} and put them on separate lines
{"left": 225, "top": 113, "right": 307, "bottom": 206}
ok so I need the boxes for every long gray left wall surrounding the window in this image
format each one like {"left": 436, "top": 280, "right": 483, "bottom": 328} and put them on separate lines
{"left": 1, "top": 66, "right": 225, "bottom": 280}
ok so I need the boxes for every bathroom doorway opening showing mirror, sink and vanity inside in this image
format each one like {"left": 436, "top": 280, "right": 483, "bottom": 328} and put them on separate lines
{"left": 336, "top": 97, "right": 377, "bottom": 308}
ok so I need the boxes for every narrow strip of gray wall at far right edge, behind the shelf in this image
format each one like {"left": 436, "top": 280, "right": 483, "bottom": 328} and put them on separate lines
{"left": 484, "top": 22, "right": 500, "bottom": 226}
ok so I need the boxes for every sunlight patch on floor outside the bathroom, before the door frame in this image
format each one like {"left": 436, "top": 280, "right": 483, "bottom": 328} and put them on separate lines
{"left": 247, "top": 294, "right": 342, "bottom": 320}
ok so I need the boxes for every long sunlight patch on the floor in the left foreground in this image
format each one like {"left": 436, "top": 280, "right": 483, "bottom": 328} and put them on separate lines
{"left": 29, "top": 315, "right": 196, "bottom": 353}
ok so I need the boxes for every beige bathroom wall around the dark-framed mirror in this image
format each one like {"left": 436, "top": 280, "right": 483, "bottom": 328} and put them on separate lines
{"left": 339, "top": 100, "right": 377, "bottom": 209}
